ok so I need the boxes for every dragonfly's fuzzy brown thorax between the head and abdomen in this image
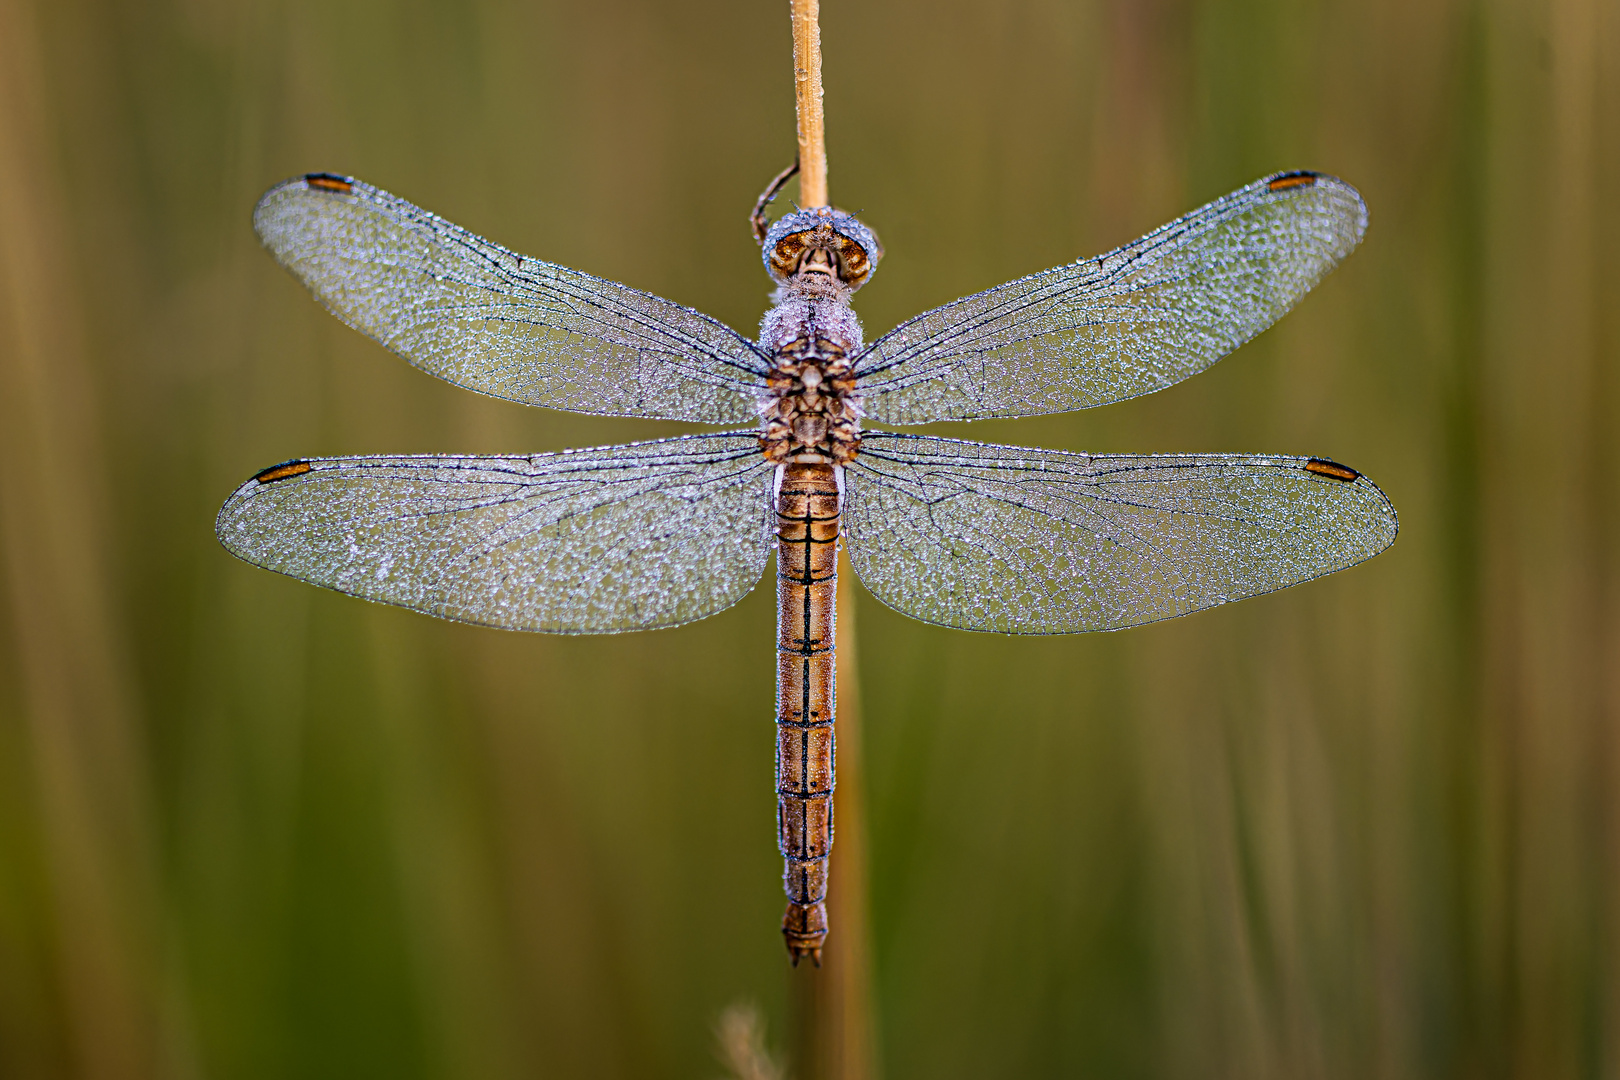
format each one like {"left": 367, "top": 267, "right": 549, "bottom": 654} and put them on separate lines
{"left": 760, "top": 296, "right": 862, "bottom": 465}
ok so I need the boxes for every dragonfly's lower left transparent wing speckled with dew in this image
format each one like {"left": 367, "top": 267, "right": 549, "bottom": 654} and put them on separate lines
{"left": 215, "top": 432, "right": 771, "bottom": 633}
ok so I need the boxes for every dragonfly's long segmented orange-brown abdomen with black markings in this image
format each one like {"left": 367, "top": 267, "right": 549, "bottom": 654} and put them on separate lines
{"left": 776, "top": 461, "right": 839, "bottom": 965}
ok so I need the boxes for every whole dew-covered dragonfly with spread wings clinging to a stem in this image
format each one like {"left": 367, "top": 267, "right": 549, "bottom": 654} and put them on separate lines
{"left": 217, "top": 172, "right": 1398, "bottom": 965}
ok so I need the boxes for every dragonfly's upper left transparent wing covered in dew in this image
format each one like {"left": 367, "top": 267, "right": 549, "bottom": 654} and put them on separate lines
{"left": 253, "top": 173, "right": 765, "bottom": 423}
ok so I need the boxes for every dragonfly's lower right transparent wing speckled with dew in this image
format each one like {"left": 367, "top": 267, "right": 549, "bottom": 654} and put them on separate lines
{"left": 844, "top": 432, "right": 1396, "bottom": 633}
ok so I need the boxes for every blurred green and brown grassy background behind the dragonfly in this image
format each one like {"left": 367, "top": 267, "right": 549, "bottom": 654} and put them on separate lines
{"left": 0, "top": 0, "right": 1620, "bottom": 1080}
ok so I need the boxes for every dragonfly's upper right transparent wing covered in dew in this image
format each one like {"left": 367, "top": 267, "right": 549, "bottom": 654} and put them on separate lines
{"left": 855, "top": 173, "right": 1367, "bottom": 424}
